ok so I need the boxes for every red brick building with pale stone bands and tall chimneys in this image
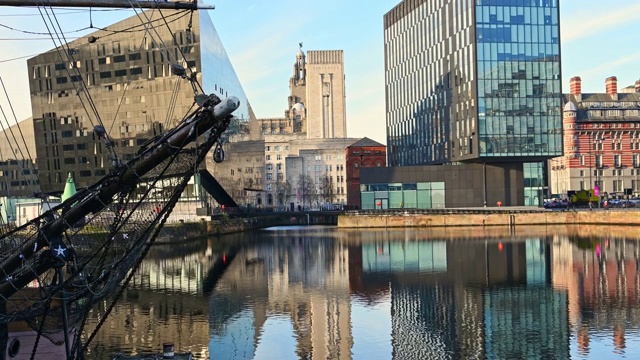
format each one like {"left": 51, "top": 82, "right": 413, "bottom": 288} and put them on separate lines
{"left": 549, "top": 76, "right": 640, "bottom": 197}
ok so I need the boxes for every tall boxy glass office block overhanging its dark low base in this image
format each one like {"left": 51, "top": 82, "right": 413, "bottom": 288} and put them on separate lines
{"left": 384, "top": 0, "right": 562, "bottom": 202}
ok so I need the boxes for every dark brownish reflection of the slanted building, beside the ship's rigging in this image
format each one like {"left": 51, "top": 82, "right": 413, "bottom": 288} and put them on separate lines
{"left": 85, "top": 245, "right": 213, "bottom": 358}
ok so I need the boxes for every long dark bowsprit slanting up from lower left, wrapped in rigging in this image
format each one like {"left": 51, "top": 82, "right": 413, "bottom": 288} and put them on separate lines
{"left": 0, "top": 96, "right": 240, "bottom": 299}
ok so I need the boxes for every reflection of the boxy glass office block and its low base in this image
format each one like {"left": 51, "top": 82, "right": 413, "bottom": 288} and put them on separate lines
{"left": 349, "top": 239, "right": 569, "bottom": 359}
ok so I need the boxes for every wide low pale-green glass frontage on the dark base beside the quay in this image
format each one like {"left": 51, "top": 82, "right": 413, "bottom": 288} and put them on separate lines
{"left": 360, "top": 182, "right": 445, "bottom": 210}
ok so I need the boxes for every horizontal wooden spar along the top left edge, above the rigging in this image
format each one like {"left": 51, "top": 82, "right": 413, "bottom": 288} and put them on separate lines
{"left": 0, "top": 0, "right": 215, "bottom": 10}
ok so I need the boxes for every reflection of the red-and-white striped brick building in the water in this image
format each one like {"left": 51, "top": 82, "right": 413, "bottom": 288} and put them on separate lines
{"left": 553, "top": 237, "right": 640, "bottom": 355}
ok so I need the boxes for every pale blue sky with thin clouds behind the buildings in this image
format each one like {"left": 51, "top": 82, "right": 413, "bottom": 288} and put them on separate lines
{"left": 0, "top": 0, "right": 640, "bottom": 143}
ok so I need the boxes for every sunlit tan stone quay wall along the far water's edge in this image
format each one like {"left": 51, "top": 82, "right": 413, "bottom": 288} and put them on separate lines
{"left": 338, "top": 209, "right": 640, "bottom": 228}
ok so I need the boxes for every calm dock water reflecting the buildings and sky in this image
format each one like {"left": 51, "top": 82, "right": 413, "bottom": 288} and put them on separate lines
{"left": 82, "top": 227, "right": 640, "bottom": 359}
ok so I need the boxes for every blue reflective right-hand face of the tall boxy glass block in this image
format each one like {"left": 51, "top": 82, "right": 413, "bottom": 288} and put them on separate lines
{"left": 475, "top": 0, "right": 562, "bottom": 158}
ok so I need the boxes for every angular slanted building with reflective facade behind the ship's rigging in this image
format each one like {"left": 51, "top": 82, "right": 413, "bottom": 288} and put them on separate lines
{"left": 27, "top": 10, "right": 253, "bottom": 196}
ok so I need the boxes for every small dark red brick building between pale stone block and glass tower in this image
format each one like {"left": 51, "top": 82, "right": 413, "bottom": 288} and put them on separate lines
{"left": 345, "top": 137, "right": 387, "bottom": 209}
